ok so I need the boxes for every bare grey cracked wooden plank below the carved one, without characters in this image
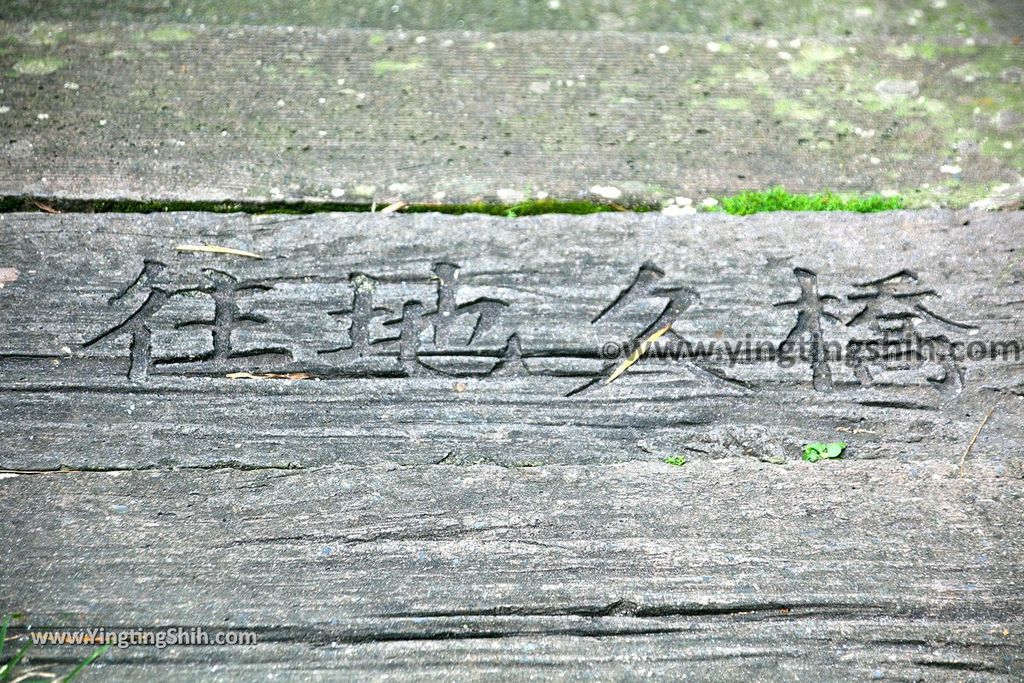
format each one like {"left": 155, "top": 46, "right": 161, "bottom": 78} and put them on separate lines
{"left": 0, "top": 461, "right": 1024, "bottom": 680}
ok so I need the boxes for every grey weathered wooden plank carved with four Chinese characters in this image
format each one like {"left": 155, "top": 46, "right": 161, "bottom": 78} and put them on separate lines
{"left": 0, "top": 211, "right": 1024, "bottom": 471}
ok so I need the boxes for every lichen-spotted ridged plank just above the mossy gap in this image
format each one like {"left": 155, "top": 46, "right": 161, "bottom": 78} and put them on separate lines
{"left": 0, "top": 23, "right": 1024, "bottom": 206}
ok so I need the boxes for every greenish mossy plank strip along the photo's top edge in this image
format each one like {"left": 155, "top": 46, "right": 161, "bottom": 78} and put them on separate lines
{"left": 0, "top": 0, "right": 1024, "bottom": 38}
